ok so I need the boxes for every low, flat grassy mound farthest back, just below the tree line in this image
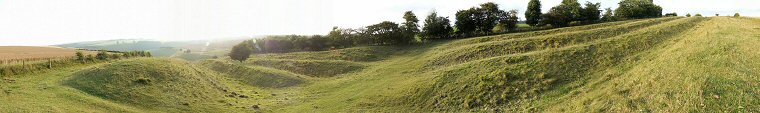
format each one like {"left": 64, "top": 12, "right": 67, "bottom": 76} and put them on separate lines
{"left": 247, "top": 59, "right": 364, "bottom": 77}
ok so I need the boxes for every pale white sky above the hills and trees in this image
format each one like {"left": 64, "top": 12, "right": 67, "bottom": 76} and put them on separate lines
{"left": 0, "top": 0, "right": 760, "bottom": 46}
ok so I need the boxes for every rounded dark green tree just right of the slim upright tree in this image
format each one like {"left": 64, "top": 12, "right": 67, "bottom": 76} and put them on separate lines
{"left": 421, "top": 12, "right": 454, "bottom": 39}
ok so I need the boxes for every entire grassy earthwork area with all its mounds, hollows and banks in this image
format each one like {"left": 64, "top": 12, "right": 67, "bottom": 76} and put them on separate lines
{"left": 0, "top": 17, "right": 760, "bottom": 112}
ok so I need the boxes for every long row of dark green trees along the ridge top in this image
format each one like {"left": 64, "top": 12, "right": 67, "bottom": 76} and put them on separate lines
{"left": 228, "top": 0, "right": 662, "bottom": 61}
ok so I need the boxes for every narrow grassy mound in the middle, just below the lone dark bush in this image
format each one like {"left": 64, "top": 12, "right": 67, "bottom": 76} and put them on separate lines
{"left": 200, "top": 59, "right": 305, "bottom": 88}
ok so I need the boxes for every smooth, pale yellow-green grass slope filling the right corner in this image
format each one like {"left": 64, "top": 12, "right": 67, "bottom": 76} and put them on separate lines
{"left": 547, "top": 17, "right": 760, "bottom": 112}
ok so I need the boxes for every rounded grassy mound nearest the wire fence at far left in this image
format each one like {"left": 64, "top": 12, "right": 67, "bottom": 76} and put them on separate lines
{"left": 65, "top": 58, "right": 232, "bottom": 110}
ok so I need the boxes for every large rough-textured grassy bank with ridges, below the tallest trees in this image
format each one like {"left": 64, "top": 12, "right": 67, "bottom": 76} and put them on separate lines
{"left": 409, "top": 18, "right": 705, "bottom": 110}
